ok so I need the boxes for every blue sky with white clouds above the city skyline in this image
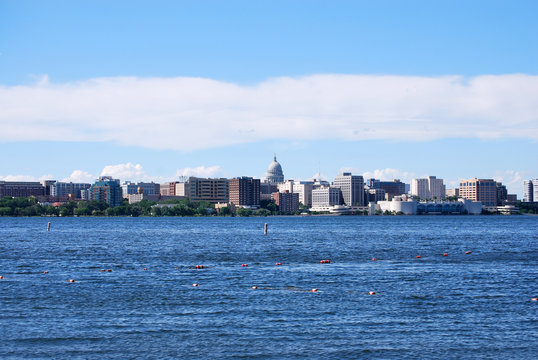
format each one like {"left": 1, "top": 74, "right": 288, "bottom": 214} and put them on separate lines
{"left": 0, "top": 0, "right": 538, "bottom": 197}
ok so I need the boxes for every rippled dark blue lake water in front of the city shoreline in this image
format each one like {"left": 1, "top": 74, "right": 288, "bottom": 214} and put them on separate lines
{"left": 0, "top": 216, "right": 538, "bottom": 359}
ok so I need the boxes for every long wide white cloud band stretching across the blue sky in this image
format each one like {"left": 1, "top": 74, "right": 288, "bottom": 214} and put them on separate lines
{"left": 0, "top": 74, "right": 538, "bottom": 151}
